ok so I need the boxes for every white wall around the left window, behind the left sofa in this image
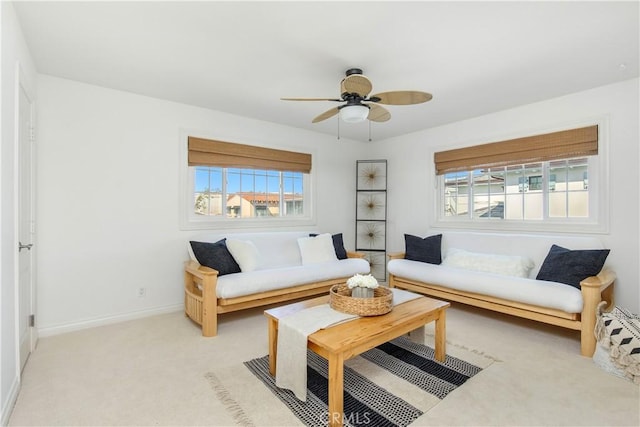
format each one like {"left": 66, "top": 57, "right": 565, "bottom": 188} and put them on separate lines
{"left": 37, "top": 75, "right": 363, "bottom": 335}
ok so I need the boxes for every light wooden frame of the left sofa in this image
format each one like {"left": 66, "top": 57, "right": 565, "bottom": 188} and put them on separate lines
{"left": 184, "top": 251, "right": 364, "bottom": 337}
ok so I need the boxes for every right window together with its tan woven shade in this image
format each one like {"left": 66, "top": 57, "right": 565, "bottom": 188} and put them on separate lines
{"left": 434, "top": 126, "right": 608, "bottom": 231}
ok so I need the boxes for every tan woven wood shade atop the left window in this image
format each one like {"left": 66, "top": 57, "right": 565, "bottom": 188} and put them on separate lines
{"left": 189, "top": 136, "right": 311, "bottom": 173}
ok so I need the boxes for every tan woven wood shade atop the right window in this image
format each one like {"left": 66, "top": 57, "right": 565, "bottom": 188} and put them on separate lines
{"left": 434, "top": 125, "right": 598, "bottom": 175}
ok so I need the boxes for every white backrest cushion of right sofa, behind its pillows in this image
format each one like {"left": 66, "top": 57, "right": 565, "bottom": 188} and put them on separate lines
{"left": 442, "top": 231, "right": 603, "bottom": 278}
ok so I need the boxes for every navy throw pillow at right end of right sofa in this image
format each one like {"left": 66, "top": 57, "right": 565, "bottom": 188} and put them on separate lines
{"left": 536, "top": 245, "right": 609, "bottom": 289}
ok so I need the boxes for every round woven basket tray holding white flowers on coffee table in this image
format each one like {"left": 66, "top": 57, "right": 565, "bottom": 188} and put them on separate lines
{"left": 329, "top": 284, "right": 393, "bottom": 316}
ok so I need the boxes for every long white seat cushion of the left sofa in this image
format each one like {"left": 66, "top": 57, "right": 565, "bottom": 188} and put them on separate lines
{"left": 216, "top": 258, "right": 370, "bottom": 298}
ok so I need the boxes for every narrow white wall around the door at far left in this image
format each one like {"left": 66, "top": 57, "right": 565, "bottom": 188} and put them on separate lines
{"left": 0, "top": 1, "right": 35, "bottom": 425}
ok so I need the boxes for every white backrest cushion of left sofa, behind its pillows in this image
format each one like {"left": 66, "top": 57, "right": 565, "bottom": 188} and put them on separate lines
{"left": 187, "top": 231, "right": 317, "bottom": 268}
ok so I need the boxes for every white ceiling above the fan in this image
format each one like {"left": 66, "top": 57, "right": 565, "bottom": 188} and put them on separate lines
{"left": 15, "top": 1, "right": 640, "bottom": 141}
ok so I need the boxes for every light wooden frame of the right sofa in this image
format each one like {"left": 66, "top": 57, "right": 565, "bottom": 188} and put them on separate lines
{"left": 389, "top": 253, "right": 616, "bottom": 357}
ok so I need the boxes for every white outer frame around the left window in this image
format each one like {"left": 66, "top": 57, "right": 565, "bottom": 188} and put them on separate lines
{"left": 178, "top": 130, "right": 316, "bottom": 230}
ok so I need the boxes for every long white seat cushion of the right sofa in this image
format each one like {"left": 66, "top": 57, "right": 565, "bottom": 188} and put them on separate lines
{"left": 384, "top": 259, "right": 583, "bottom": 313}
